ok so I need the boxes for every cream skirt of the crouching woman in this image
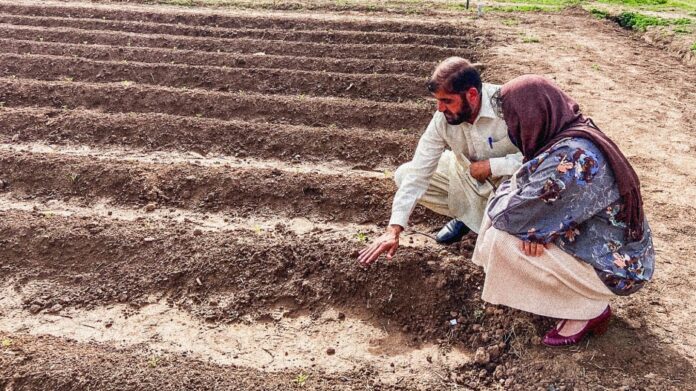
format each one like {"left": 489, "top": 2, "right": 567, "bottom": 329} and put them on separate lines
{"left": 473, "top": 214, "right": 614, "bottom": 320}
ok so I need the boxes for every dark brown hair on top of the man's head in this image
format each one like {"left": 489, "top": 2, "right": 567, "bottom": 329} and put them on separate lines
{"left": 428, "top": 57, "right": 481, "bottom": 94}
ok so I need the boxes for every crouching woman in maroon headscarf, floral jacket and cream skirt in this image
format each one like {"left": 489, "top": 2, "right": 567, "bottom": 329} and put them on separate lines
{"left": 474, "top": 75, "right": 655, "bottom": 346}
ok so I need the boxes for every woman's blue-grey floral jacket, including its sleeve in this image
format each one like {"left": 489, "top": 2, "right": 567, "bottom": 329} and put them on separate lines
{"left": 489, "top": 137, "right": 655, "bottom": 295}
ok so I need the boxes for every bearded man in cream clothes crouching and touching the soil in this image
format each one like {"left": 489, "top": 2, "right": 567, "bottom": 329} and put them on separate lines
{"left": 358, "top": 57, "right": 522, "bottom": 264}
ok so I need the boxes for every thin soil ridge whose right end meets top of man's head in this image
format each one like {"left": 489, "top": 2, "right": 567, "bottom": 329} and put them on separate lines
{"left": 0, "top": 38, "right": 435, "bottom": 77}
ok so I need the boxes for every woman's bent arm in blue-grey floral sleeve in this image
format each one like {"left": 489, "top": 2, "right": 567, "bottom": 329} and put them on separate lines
{"left": 488, "top": 138, "right": 619, "bottom": 244}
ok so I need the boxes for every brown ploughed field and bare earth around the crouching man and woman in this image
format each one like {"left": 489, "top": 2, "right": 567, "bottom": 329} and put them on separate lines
{"left": 0, "top": 2, "right": 696, "bottom": 390}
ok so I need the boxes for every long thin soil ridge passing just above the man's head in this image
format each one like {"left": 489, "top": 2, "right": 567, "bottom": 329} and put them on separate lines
{"left": 0, "top": 24, "right": 468, "bottom": 62}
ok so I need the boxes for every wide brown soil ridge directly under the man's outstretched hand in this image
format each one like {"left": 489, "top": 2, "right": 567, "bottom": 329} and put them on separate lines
{"left": 0, "top": 211, "right": 482, "bottom": 338}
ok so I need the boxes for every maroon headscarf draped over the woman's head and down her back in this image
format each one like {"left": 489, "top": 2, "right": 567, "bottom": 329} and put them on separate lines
{"left": 500, "top": 75, "right": 644, "bottom": 240}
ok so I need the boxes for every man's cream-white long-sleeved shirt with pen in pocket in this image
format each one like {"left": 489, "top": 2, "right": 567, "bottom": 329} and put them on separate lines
{"left": 389, "top": 83, "right": 522, "bottom": 228}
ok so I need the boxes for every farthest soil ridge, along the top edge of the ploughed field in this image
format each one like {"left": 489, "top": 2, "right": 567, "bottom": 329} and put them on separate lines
{"left": 0, "top": 3, "right": 474, "bottom": 36}
